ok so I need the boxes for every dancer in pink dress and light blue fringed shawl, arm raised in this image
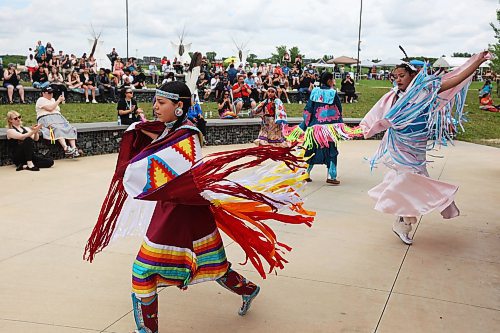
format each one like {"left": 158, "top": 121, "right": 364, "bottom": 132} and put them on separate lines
{"left": 360, "top": 52, "right": 489, "bottom": 245}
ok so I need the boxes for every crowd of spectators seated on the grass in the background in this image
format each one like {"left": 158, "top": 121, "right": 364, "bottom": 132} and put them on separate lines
{"left": 0, "top": 41, "right": 355, "bottom": 107}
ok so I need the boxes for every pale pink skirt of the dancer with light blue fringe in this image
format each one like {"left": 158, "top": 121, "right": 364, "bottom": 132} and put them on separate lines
{"left": 368, "top": 170, "right": 460, "bottom": 219}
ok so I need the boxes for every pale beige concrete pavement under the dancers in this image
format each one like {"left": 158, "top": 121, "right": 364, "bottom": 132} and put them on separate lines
{"left": 0, "top": 141, "right": 500, "bottom": 333}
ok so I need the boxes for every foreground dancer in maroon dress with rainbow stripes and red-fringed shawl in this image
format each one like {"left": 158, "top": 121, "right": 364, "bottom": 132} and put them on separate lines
{"left": 84, "top": 82, "right": 314, "bottom": 333}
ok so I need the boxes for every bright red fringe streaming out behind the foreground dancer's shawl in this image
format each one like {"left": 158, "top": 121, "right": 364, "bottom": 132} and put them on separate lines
{"left": 192, "top": 146, "right": 314, "bottom": 278}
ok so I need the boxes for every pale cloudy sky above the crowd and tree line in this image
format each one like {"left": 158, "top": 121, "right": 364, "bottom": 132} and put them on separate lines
{"left": 0, "top": 0, "right": 500, "bottom": 60}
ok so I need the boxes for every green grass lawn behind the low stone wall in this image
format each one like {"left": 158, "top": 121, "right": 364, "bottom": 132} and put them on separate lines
{"left": 0, "top": 80, "right": 500, "bottom": 147}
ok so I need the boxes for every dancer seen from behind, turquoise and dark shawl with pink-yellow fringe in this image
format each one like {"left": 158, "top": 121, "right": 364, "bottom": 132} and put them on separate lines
{"left": 286, "top": 72, "right": 362, "bottom": 185}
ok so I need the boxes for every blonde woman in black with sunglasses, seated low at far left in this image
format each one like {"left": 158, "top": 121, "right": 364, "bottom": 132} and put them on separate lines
{"left": 6, "top": 111, "right": 54, "bottom": 171}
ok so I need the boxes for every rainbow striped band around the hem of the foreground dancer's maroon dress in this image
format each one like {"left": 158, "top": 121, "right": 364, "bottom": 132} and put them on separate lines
{"left": 132, "top": 229, "right": 228, "bottom": 297}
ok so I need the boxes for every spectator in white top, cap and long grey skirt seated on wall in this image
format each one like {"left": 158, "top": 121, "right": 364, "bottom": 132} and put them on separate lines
{"left": 35, "top": 87, "right": 80, "bottom": 157}
